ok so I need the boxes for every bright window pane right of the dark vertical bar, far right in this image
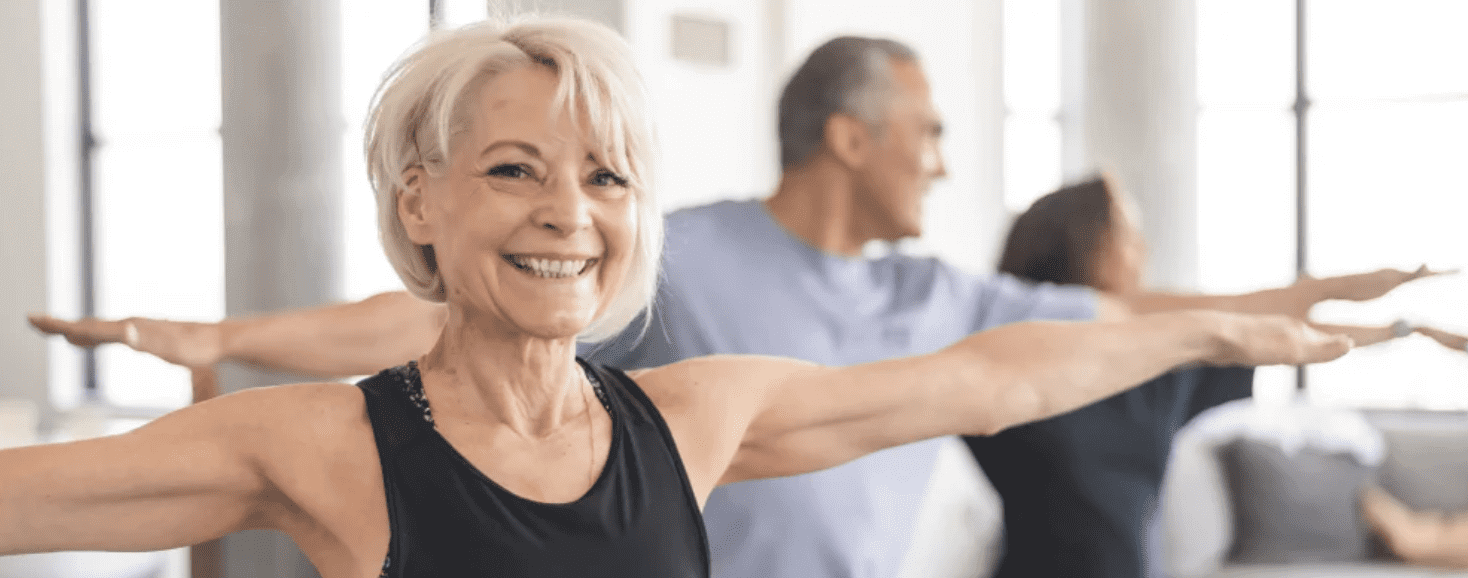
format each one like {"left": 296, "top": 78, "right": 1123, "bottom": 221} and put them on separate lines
{"left": 1302, "top": 0, "right": 1468, "bottom": 409}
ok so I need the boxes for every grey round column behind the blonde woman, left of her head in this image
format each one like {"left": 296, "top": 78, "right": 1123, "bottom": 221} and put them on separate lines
{"left": 220, "top": 0, "right": 345, "bottom": 578}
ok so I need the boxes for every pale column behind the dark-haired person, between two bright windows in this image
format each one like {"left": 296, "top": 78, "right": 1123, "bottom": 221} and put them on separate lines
{"left": 1080, "top": 0, "right": 1198, "bottom": 289}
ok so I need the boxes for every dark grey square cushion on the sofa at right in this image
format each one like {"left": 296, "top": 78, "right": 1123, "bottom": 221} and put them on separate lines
{"left": 1218, "top": 439, "right": 1373, "bottom": 563}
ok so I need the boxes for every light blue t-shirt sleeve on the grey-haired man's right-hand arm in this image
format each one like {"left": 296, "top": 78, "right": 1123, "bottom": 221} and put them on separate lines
{"left": 973, "top": 274, "right": 1098, "bottom": 332}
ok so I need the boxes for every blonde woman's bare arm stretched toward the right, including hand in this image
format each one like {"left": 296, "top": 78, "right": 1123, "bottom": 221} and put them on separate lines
{"left": 639, "top": 306, "right": 1351, "bottom": 487}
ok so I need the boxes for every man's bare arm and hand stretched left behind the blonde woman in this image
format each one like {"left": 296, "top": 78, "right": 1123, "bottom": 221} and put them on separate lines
{"left": 31, "top": 292, "right": 446, "bottom": 377}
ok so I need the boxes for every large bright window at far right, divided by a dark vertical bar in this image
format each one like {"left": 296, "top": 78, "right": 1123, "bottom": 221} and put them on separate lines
{"left": 1198, "top": 0, "right": 1468, "bottom": 409}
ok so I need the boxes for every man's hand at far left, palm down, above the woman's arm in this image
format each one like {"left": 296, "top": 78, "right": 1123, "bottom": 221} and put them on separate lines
{"left": 29, "top": 314, "right": 223, "bottom": 368}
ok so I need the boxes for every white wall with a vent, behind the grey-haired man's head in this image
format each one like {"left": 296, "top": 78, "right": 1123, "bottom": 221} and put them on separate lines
{"left": 627, "top": 0, "right": 1009, "bottom": 270}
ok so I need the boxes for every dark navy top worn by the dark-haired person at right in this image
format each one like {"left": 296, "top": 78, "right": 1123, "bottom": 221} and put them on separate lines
{"left": 964, "top": 367, "right": 1254, "bottom": 578}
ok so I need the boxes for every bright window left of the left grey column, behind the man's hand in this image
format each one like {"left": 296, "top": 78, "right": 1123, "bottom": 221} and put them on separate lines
{"left": 79, "top": 0, "right": 225, "bottom": 408}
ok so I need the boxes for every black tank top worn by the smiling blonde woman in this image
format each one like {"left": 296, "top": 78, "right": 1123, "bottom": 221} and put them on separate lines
{"left": 358, "top": 359, "right": 709, "bottom": 578}
